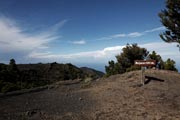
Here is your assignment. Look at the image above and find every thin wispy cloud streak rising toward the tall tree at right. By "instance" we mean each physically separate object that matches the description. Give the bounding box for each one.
[98,27,165,40]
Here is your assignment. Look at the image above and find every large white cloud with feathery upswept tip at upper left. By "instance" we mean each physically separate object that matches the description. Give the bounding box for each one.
[0,17,66,53]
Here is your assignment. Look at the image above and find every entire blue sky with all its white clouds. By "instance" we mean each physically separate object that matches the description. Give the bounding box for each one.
[0,0,180,71]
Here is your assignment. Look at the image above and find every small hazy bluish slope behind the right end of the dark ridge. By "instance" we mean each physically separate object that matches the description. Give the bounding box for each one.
[80,67,104,78]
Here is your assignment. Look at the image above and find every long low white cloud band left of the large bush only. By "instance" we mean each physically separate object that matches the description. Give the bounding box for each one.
[28,46,124,62]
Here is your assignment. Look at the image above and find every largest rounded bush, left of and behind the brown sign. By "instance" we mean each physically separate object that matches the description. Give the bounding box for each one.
[105,44,149,77]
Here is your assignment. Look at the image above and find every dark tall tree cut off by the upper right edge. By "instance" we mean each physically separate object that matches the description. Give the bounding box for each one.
[159,0,180,50]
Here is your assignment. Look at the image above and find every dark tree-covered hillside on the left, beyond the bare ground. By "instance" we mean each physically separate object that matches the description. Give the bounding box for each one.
[0,61,104,93]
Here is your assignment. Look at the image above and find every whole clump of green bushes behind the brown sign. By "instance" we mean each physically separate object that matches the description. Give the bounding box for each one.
[105,44,177,77]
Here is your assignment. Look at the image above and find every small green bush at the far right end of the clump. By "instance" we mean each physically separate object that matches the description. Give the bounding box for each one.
[164,58,177,71]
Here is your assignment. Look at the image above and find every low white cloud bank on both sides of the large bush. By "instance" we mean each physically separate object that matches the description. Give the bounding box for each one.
[28,42,180,64]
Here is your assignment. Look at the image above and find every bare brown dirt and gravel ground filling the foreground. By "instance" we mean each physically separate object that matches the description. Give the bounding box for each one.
[0,70,180,120]
